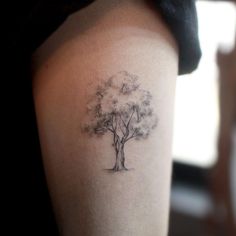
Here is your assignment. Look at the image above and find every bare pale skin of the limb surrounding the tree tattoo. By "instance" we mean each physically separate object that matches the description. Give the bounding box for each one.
[32,0,178,236]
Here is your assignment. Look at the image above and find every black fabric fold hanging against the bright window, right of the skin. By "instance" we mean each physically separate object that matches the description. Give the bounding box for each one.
[155,0,201,75]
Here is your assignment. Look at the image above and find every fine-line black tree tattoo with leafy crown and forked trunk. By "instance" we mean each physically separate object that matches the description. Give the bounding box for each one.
[83,71,157,171]
